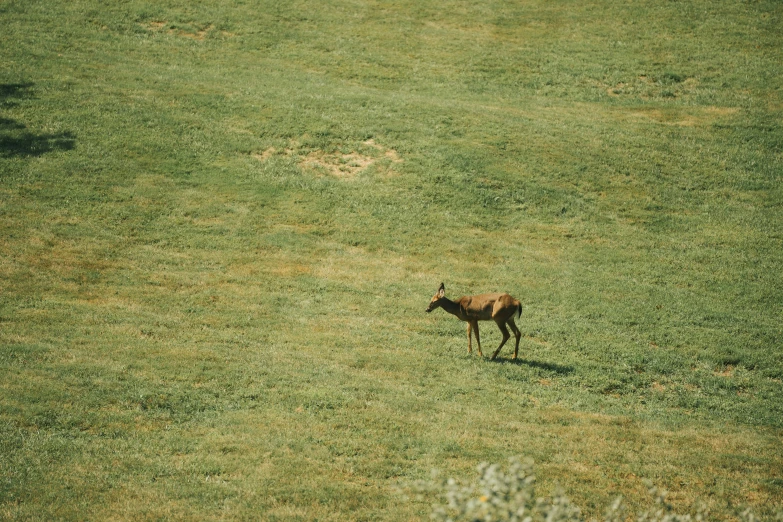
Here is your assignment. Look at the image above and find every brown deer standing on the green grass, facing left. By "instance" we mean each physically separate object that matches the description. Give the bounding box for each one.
[426,283,522,360]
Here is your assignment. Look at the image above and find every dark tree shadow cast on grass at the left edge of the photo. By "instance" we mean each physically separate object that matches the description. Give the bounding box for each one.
[0,83,76,158]
